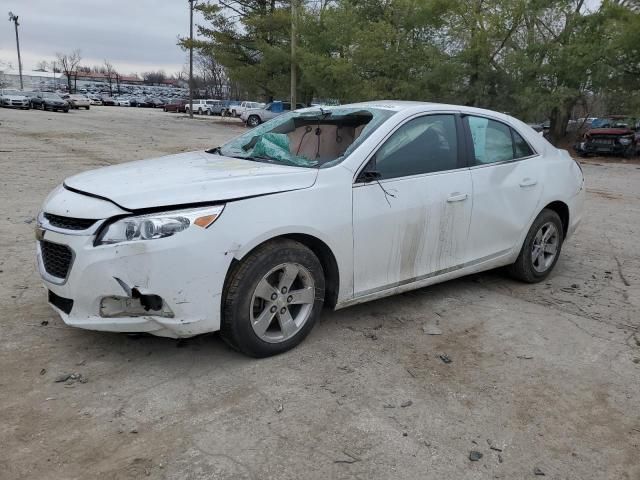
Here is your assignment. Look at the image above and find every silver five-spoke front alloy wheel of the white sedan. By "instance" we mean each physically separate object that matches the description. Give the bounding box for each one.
[250,263,315,343]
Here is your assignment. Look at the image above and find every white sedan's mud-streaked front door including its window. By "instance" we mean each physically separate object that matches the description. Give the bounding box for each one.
[353,113,472,296]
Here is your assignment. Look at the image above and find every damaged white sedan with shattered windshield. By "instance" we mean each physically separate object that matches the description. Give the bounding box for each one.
[36,101,585,357]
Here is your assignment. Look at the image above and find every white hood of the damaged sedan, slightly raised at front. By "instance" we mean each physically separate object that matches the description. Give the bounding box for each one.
[64,152,318,210]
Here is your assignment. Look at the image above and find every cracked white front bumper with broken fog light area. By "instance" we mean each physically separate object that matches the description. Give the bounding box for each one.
[37,212,231,338]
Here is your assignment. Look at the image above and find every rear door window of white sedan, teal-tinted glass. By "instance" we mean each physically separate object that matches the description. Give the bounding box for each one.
[464,116,514,165]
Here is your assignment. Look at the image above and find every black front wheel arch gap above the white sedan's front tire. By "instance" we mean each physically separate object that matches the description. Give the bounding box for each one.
[223,233,340,308]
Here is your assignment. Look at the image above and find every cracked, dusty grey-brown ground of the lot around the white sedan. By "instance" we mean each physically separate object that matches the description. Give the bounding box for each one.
[0,107,640,480]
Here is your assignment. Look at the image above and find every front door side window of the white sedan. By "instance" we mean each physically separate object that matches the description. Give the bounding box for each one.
[374,115,458,178]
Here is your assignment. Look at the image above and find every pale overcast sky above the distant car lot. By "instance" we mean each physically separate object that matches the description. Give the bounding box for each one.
[0,0,202,74]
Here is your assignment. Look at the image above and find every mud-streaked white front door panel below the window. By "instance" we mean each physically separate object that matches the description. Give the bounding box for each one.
[353,168,472,296]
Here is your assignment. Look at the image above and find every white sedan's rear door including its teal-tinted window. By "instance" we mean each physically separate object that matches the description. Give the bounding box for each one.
[463,115,543,263]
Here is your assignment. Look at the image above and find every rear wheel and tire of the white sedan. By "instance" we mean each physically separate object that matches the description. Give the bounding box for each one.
[507,208,564,283]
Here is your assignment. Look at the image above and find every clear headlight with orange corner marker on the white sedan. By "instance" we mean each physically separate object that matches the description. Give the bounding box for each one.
[96,205,224,245]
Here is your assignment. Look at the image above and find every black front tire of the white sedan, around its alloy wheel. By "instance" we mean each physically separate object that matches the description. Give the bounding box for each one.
[221,240,324,358]
